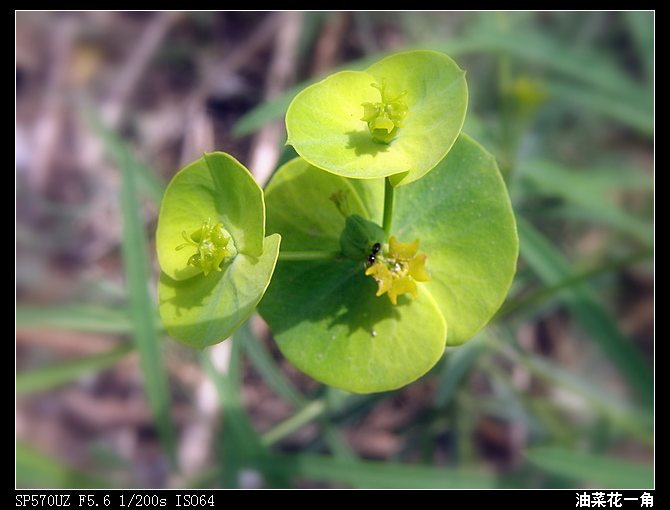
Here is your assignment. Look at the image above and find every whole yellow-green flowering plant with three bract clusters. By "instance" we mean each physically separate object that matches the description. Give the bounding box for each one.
[157,51,518,393]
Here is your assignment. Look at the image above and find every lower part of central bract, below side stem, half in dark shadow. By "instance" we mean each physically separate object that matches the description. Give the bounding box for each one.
[260,260,447,393]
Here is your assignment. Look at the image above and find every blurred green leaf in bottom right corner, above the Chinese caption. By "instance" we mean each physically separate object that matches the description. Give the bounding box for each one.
[525,447,654,489]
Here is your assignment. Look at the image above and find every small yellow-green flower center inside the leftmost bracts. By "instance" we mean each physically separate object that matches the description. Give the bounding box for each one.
[175,218,236,276]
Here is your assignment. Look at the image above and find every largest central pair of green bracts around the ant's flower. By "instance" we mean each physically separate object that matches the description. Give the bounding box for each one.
[259,135,518,393]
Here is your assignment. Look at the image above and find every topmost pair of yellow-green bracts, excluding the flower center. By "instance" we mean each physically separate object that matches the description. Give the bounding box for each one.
[286,50,468,186]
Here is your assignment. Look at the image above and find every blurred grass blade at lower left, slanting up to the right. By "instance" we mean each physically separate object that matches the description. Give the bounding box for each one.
[16,346,131,395]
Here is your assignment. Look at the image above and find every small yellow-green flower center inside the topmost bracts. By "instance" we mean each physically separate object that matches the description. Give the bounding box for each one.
[361,79,408,143]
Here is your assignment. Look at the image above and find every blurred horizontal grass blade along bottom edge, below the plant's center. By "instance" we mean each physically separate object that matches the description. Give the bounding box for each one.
[264,454,495,489]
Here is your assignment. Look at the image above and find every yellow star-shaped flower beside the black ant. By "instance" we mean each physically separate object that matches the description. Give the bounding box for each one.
[365,236,430,305]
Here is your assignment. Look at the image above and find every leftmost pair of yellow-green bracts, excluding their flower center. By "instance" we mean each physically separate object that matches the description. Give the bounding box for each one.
[156,152,280,348]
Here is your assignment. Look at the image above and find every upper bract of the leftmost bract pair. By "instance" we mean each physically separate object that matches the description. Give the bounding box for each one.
[156,152,265,280]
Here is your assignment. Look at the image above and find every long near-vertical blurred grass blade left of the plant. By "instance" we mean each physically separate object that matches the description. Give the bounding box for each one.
[113,128,177,465]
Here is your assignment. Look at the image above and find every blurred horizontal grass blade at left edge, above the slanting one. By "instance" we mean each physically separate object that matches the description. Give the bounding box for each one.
[16,305,163,335]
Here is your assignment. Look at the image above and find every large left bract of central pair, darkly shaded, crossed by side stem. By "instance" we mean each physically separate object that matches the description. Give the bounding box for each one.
[259,159,446,393]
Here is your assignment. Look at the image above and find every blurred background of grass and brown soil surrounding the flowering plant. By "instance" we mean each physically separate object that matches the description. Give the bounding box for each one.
[16,12,654,488]
